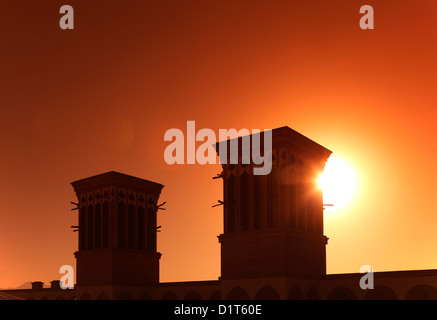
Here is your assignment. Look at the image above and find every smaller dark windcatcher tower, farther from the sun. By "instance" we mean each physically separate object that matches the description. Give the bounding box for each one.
[72,171,163,287]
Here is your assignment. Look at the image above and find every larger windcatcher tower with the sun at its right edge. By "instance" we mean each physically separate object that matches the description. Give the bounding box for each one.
[218,127,331,279]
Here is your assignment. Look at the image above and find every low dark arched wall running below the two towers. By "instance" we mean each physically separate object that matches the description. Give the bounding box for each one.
[2,270,437,300]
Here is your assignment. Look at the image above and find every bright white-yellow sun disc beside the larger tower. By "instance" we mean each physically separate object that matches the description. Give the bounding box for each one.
[318,155,357,209]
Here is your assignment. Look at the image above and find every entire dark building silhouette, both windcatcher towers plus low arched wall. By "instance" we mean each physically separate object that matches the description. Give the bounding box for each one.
[0,127,437,300]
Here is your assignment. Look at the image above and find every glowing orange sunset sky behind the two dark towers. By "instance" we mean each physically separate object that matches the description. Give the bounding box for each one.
[0,0,437,287]
